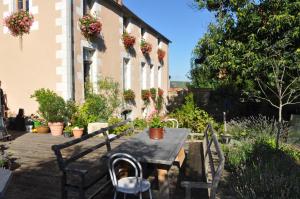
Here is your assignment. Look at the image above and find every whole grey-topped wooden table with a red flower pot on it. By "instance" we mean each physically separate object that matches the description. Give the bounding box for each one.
[108,128,190,199]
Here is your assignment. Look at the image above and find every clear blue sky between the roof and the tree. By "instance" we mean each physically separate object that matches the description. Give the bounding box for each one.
[123,0,214,81]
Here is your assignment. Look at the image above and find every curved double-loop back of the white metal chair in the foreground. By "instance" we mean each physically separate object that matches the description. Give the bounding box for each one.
[108,153,143,187]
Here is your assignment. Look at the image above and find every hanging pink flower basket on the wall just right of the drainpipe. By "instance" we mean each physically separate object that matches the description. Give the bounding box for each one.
[79,14,102,41]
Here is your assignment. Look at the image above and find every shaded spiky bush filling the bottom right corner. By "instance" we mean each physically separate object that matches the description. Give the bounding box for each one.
[225,137,300,199]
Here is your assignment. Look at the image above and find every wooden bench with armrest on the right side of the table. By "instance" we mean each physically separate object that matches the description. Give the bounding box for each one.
[181,124,225,199]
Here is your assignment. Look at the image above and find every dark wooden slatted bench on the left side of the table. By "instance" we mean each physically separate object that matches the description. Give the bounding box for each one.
[52,120,133,199]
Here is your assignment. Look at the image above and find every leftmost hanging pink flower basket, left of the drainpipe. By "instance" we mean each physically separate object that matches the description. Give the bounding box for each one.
[4,10,34,37]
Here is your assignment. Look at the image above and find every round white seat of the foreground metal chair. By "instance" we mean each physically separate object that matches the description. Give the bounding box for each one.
[116,177,151,194]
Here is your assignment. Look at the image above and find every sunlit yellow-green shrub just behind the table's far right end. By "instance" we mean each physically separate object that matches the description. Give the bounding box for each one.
[169,94,217,133]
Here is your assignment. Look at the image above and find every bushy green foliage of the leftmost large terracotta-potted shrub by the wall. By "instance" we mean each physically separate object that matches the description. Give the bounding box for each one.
[31,88,69,122]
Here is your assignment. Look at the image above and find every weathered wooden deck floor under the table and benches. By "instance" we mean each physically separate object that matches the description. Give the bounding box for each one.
[0,132,205,199]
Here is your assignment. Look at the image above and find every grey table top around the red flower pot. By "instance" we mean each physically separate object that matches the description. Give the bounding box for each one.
[108,128,190,166]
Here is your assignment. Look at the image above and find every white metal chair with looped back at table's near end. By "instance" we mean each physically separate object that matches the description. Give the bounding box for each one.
[108,153,152,199]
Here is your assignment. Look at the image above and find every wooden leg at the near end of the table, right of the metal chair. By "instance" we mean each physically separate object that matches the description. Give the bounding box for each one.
[157,167,170,199]
